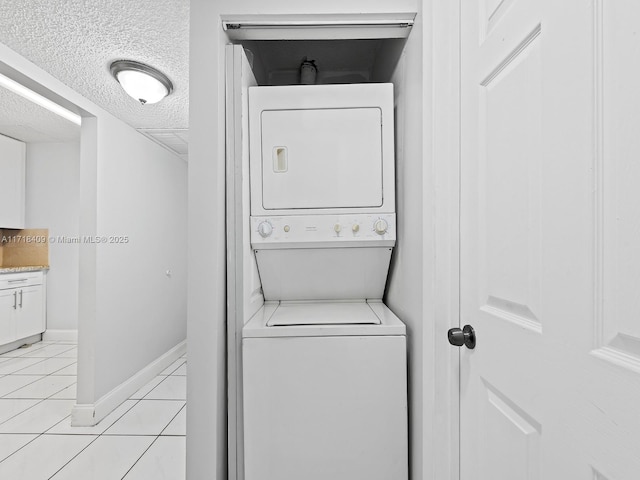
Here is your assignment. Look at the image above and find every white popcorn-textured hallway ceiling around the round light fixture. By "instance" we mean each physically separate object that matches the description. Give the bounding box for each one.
[0,0,189,135]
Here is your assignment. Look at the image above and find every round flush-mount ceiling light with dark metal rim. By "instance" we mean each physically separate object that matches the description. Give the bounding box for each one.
[110,60,173,105]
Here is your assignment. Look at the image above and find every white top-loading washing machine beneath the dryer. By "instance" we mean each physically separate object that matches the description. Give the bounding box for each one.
[242,301,408,480]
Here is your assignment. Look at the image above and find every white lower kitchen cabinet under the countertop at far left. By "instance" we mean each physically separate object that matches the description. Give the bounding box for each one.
[0,272,46,345]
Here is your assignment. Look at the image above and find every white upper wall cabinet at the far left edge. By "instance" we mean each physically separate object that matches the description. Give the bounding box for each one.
[0,131,26,228]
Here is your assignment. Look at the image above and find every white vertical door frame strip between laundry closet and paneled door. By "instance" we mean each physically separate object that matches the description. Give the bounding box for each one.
[420,0,462,480]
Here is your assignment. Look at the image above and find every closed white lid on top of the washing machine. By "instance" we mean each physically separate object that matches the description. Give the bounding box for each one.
[267,301,381,327]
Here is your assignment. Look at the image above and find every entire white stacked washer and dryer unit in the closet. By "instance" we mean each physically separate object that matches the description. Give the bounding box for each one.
[242,84,408,480]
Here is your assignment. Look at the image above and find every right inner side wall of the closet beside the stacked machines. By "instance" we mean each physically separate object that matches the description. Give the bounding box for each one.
[384,10,431,479]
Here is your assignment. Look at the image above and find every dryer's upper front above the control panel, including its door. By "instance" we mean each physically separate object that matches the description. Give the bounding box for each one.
[249,83,395,216]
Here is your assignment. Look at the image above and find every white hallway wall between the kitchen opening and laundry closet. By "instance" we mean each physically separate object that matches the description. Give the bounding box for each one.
[78,114,187,403]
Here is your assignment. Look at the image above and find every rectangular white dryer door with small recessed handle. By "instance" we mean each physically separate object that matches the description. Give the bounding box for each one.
[261,107,382,210]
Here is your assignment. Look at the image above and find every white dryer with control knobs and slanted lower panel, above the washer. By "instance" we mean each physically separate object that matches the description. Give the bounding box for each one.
[249,84,396,300]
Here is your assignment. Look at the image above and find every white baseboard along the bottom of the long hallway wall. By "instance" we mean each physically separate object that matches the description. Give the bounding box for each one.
[71,340,187,427]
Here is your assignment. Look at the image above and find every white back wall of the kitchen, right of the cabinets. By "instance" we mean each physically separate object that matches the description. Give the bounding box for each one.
[26,142,80,330]
